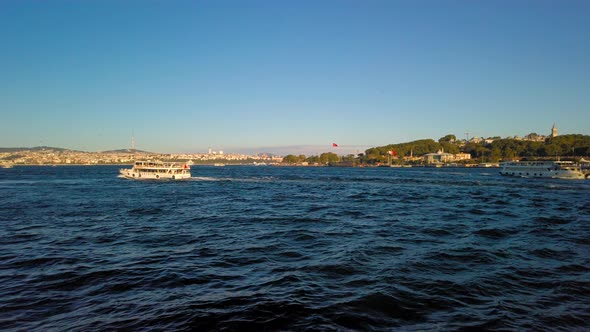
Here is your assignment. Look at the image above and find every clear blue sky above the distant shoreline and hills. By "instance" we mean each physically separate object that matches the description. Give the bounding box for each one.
[0,0,590,152]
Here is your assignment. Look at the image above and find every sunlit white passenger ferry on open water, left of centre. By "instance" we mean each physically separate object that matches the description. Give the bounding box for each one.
[120,160,191,180]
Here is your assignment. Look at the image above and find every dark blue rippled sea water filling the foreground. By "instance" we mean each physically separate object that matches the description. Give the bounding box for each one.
[0,166,590,331]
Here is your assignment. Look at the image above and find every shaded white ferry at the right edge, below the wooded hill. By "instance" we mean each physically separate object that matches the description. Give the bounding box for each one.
[500,161,590,179]
